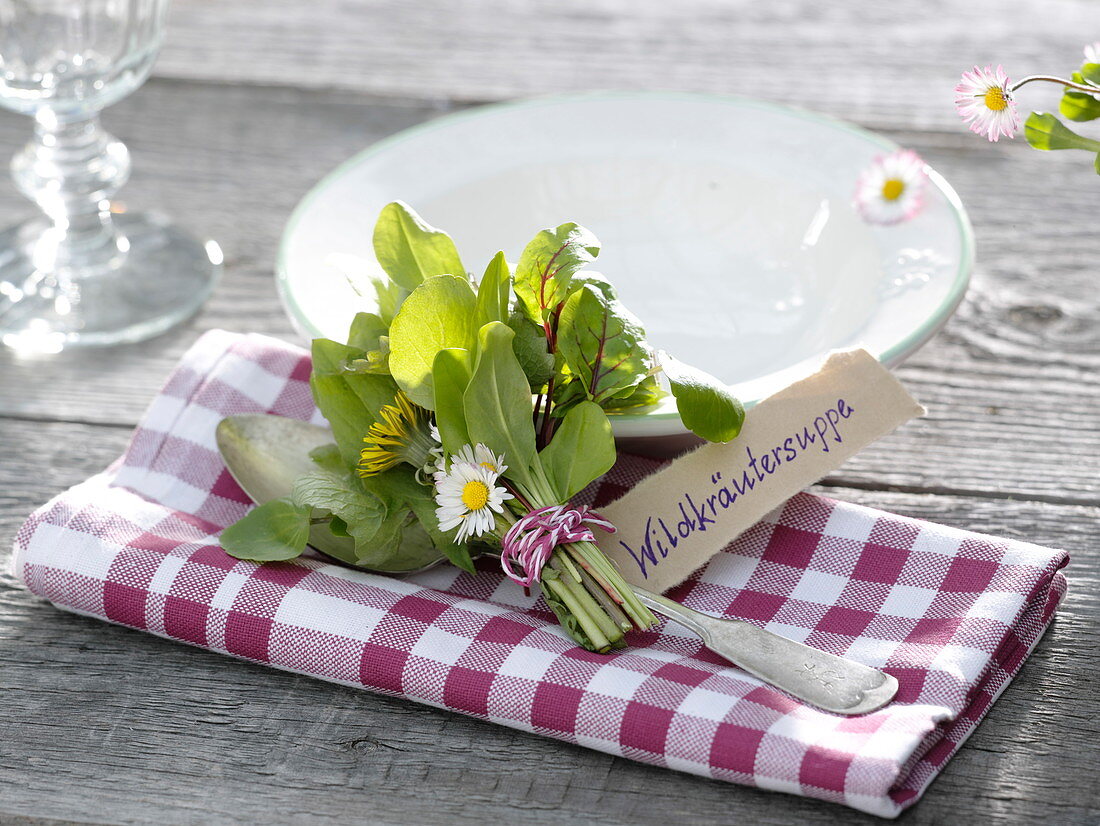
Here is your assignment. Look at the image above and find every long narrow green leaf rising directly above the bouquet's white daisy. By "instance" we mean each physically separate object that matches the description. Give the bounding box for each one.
[463,321,536,487]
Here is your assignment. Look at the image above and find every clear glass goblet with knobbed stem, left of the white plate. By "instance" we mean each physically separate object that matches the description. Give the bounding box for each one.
[0,0,221,353]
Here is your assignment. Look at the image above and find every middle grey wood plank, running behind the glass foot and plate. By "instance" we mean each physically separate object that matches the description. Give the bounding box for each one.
[0,81,1100,504]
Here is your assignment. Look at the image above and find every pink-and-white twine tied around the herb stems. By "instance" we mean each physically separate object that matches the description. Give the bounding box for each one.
[501,505,615,588]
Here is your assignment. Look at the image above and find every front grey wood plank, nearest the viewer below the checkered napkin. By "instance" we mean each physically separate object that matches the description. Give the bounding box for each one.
[0,420,1100,824]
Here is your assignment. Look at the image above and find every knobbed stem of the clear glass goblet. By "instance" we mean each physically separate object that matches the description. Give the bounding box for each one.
[11,110,130,280]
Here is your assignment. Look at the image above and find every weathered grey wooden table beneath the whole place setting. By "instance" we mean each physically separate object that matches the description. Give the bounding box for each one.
[0,0,1100,824]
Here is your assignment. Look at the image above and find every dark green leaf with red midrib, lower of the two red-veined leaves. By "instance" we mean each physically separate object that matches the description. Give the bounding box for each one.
[558,285,653,403]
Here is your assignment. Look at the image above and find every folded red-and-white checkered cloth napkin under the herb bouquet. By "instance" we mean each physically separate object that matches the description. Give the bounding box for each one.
[13,332,1067,817]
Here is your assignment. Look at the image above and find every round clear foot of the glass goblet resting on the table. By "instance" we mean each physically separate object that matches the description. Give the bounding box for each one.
[0,212,222,354]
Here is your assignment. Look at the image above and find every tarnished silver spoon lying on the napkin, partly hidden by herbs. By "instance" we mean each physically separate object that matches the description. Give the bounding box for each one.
[217,415,898,715]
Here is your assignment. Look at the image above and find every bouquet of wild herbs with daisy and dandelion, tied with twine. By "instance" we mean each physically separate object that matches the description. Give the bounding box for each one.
[221,202,745,651]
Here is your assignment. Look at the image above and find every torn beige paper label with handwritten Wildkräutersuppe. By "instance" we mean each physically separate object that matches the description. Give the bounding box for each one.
[596,350,924,593]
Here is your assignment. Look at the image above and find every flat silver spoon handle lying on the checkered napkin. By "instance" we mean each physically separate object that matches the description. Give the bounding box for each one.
[634,587,898,715]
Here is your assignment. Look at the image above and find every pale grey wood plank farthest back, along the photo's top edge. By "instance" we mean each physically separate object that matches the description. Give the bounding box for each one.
[156,0,1100,128]
